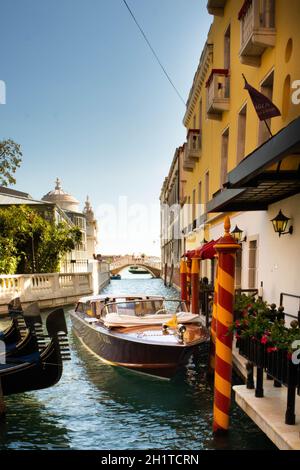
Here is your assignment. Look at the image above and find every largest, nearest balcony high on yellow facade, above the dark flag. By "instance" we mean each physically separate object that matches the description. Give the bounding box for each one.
[238,0,276,67]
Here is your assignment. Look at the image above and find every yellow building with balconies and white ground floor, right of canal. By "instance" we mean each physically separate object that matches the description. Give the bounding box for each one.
[162,0,300,309]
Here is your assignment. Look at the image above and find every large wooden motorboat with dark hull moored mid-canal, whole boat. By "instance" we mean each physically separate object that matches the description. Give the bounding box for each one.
[70,295,209,379]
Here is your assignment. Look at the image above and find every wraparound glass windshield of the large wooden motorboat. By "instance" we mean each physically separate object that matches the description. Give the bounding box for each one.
[101,299,188,317]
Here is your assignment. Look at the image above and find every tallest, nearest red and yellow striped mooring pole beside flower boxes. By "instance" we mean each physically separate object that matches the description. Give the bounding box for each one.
[213,216,240,434]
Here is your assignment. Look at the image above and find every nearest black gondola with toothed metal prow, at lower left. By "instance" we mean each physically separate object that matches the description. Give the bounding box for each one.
[0,308,70,396]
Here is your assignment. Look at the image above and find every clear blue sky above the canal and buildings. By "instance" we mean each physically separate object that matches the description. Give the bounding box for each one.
[0,0,211,253]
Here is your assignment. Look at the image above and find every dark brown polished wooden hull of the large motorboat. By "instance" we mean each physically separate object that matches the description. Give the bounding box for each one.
[71,312,207,379]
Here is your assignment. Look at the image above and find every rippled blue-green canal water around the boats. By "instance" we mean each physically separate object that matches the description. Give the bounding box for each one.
[0,271,274,450]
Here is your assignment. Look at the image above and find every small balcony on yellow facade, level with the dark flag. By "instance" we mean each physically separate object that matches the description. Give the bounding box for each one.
[206,69,230,120]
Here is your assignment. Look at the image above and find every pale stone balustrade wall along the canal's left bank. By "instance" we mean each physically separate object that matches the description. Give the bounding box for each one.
[0,261,110,315]
